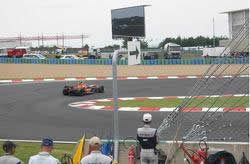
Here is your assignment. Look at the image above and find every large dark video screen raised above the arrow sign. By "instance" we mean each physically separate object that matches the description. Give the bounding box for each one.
[111,6,145,39]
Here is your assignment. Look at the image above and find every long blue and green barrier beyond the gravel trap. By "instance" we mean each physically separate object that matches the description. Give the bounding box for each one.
[0,57,249,65]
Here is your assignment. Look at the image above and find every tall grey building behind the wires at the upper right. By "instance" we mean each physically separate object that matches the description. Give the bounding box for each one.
[220,8,249,52]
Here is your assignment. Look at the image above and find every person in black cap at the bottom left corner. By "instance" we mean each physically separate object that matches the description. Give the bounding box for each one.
[0,141,23,164]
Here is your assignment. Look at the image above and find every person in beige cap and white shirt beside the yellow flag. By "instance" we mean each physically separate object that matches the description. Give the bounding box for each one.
[81,137,112,164]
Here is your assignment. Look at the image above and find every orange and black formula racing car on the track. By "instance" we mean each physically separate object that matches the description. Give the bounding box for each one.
[63,82,104,96]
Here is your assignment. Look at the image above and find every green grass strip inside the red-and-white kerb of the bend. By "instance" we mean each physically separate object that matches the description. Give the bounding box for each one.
[97,96,249,108]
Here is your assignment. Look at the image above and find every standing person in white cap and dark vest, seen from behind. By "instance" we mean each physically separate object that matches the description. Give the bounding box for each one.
[137,113,158,164]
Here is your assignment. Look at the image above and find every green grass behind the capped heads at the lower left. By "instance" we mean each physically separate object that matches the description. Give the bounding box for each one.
[0,142,75,163]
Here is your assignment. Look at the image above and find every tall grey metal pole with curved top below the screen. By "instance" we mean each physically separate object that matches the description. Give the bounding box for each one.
[112,50,119,163]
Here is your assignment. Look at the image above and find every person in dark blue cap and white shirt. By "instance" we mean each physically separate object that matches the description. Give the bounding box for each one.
[29,138,60,164]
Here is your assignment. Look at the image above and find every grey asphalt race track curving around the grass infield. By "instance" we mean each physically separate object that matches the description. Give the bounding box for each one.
[0,78,249,142]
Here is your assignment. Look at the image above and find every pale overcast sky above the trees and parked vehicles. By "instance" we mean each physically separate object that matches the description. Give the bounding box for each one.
[0,0,249,47]
